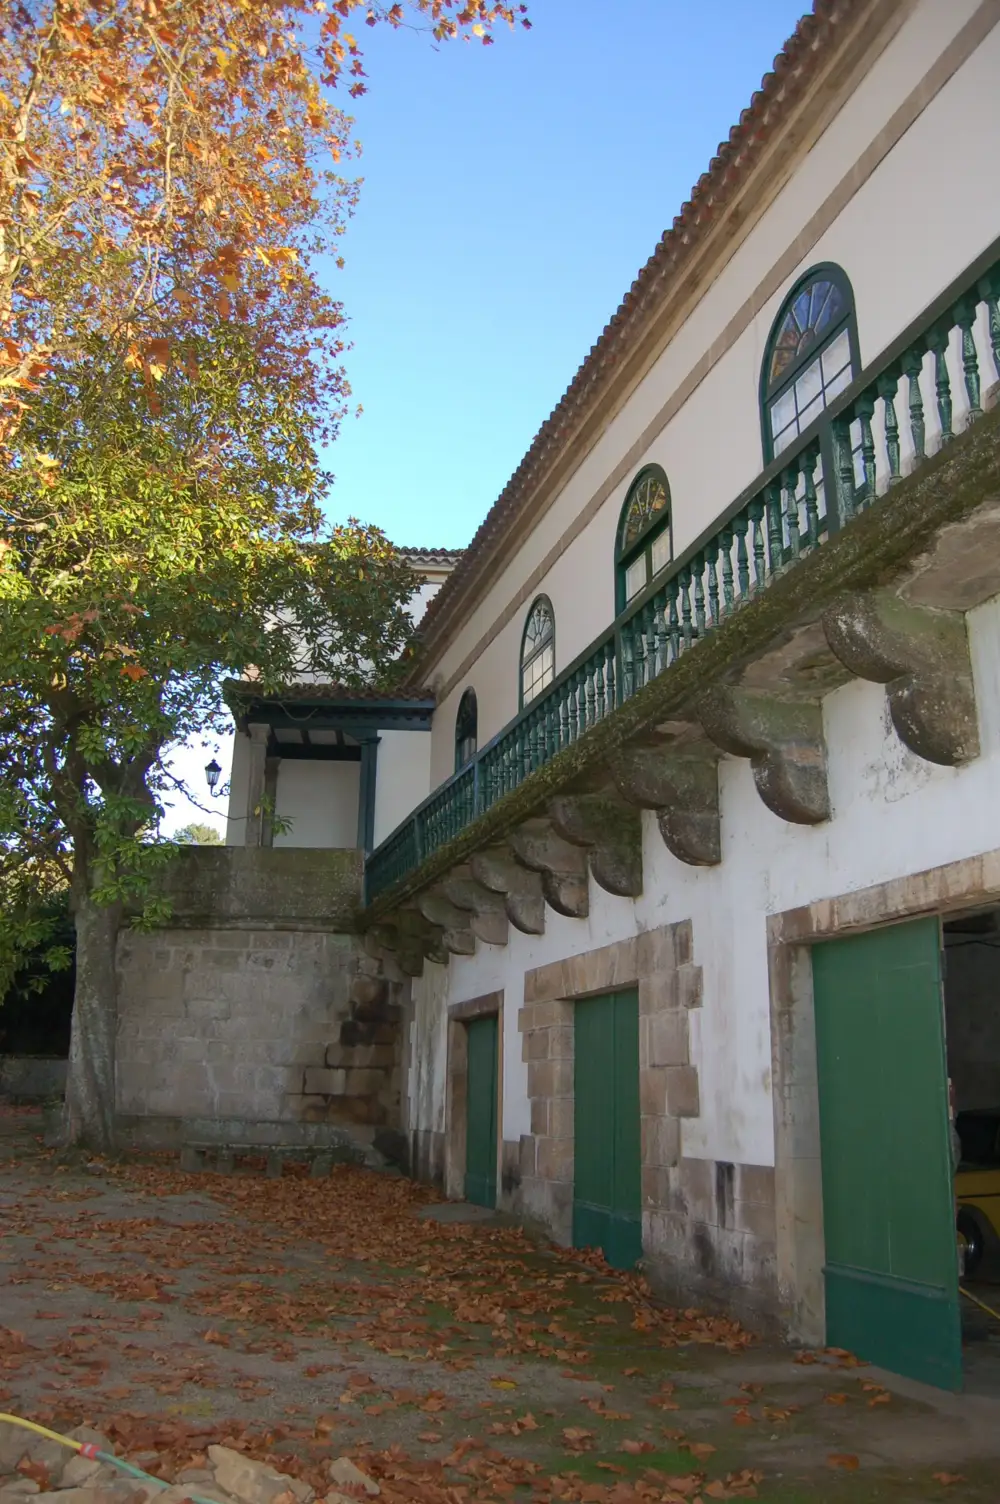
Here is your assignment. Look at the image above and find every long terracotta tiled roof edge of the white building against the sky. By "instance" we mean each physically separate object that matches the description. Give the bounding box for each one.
[411,0,865,675]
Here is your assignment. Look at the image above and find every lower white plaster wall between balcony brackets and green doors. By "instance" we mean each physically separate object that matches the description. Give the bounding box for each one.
[414,597,1000,1164]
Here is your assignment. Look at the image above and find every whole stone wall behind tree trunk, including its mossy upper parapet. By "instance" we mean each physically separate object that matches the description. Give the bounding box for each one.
[117,847,402,1146]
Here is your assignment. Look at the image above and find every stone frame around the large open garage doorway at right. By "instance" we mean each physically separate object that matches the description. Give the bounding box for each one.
[767,850,1000,1345]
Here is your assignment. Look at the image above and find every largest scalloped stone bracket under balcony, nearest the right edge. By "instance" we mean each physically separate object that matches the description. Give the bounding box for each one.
[823,591,979,767]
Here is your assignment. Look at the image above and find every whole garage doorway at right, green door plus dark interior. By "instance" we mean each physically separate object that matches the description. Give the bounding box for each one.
[812,907,1000,1396]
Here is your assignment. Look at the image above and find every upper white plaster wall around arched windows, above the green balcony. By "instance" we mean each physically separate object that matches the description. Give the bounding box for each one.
[432,0,1000,787]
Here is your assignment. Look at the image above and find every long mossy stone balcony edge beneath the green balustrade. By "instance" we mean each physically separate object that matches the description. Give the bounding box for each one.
[361,408,1000,926]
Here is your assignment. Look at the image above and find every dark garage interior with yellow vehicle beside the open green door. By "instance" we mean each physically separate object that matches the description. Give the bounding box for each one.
[943,908,1000,1394]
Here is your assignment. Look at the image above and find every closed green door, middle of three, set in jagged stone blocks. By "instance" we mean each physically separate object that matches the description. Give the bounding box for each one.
[573,991,642,1269]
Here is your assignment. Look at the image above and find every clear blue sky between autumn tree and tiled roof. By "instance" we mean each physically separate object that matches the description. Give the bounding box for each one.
[326,0,805,547]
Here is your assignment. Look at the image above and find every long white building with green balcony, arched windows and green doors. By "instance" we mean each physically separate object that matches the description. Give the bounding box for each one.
[224,0,1000,1387]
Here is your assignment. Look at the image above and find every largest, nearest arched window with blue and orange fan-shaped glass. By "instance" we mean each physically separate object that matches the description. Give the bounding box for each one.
[761,263,860,462]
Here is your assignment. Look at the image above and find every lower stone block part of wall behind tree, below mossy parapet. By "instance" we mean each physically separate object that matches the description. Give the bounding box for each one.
[117,929,400,1126]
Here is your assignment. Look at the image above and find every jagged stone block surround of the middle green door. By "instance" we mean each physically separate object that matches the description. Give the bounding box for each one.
[517,920,702,1244]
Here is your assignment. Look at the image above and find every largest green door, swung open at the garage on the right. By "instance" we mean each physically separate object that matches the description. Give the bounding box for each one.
[812,919,962,1390]
